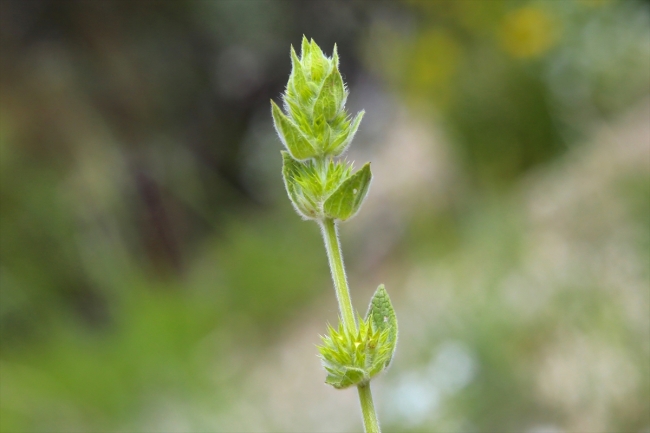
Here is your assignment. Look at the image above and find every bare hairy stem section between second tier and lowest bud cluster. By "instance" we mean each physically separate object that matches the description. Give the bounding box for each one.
[321,218,357,331]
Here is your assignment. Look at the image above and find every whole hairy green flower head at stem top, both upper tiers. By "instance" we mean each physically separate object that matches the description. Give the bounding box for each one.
[271,37,372,221]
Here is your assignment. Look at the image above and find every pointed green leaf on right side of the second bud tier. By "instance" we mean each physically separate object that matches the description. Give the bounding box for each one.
[323,163,372,221]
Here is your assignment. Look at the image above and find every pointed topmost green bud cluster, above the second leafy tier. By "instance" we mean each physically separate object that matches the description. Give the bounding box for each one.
[271,36,364,161]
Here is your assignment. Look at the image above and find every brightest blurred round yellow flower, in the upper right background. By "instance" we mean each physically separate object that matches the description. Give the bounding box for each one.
[499,6,557,58]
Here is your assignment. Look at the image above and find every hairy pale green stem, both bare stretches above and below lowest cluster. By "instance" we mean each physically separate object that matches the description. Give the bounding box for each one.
[321,218,381,433]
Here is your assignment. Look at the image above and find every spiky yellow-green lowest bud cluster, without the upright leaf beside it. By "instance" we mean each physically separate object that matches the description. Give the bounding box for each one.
[318,317,392,389]
